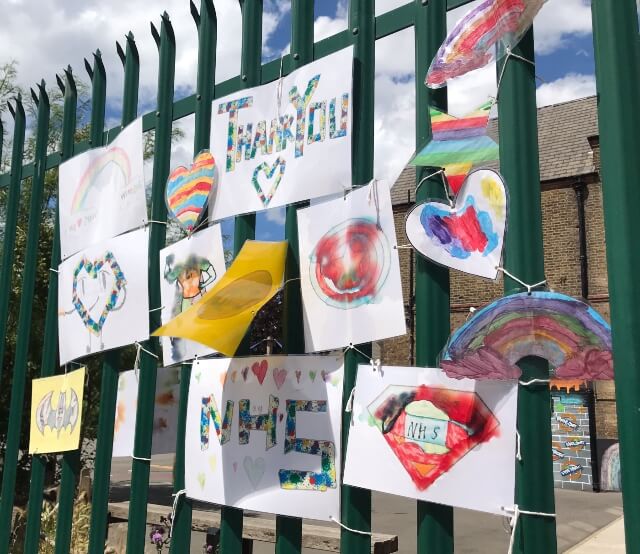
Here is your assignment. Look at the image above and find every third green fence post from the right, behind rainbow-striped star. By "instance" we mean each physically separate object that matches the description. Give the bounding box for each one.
[414,0,453,554]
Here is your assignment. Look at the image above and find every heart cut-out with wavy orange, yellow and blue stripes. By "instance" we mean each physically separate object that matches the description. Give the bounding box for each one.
[166,150,216,232]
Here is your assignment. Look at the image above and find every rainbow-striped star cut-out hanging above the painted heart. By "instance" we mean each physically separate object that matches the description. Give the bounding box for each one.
[410,102,499,194]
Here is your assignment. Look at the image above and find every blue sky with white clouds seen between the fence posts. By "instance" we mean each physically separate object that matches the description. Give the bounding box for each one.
[0,0,595,247]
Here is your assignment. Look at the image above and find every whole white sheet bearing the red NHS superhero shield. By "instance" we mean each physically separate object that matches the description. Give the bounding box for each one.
[344,365,518,515]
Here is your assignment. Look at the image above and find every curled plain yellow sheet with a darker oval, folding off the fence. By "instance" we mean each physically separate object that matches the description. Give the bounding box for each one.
[153,240,287,356]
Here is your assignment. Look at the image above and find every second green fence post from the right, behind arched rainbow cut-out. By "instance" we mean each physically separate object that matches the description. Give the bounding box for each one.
[498,30,557,554]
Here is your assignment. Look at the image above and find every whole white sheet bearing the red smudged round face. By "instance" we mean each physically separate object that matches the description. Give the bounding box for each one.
[298,182,406,352]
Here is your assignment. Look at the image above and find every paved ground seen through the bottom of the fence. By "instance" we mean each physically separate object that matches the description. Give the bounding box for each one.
[111,456,624,554]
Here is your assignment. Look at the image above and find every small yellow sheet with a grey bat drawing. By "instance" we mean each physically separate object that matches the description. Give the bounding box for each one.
[29,367,85,454]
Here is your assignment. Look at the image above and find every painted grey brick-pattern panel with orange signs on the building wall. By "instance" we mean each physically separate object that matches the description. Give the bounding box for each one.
[551,392,593,490]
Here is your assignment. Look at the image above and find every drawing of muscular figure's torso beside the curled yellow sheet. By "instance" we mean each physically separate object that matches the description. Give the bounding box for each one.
[164,254,217,360]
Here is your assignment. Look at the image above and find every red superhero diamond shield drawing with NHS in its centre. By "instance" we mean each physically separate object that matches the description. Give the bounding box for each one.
[368,385,500,491]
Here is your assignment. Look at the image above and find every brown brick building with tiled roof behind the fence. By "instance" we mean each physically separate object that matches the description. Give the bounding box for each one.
[378,97,617,489]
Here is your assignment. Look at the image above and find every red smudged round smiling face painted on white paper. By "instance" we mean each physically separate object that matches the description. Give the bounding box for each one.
[309,218,391,310]
